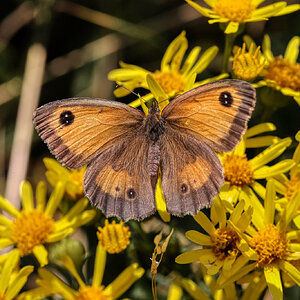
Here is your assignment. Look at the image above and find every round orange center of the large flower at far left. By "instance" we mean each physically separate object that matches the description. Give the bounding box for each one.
[12,210,55,256]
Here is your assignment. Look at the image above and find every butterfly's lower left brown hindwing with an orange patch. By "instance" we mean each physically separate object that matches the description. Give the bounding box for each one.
[84,132,156,221]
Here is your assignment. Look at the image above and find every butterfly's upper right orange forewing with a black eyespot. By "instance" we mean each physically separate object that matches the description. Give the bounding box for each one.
[162,80,255,152]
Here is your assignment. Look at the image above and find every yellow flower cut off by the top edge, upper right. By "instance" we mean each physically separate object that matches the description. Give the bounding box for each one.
[185,0,300,33]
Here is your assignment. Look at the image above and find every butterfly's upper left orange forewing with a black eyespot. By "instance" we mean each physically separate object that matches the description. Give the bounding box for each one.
[33,98,144,168]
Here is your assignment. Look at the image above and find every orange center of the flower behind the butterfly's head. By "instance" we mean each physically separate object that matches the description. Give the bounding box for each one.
[152,70,185,95]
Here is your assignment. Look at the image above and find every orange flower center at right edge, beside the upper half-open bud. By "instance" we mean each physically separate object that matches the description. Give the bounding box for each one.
[265,57,300,92]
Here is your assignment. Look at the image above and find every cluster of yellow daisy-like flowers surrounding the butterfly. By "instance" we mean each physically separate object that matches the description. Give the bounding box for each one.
[0,0,300,300]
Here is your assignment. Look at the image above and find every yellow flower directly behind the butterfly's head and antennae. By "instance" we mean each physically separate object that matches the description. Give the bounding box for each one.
[108,31,228,107]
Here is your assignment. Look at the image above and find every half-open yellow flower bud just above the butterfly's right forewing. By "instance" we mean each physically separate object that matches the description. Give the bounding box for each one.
[232,43,265,81]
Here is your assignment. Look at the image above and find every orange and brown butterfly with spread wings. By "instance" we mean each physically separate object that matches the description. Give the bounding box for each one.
[34,80,255,221]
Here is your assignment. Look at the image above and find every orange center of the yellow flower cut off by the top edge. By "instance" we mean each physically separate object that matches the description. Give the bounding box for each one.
[214,0,256,23]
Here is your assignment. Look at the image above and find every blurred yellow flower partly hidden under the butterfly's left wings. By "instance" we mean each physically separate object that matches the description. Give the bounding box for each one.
[43,157,86,199]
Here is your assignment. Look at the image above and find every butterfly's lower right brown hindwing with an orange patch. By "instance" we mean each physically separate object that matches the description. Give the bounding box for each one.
[161,128,224,216]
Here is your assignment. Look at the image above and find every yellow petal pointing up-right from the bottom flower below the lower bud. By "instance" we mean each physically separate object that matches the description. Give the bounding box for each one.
[104,263,145,299]
